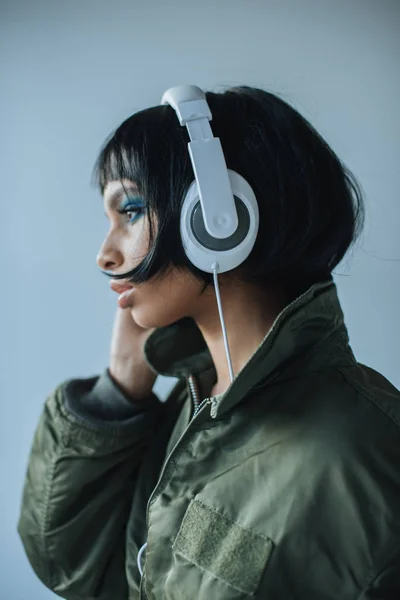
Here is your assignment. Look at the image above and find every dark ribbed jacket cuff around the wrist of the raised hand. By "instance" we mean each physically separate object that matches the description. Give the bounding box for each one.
[63,368,162,426]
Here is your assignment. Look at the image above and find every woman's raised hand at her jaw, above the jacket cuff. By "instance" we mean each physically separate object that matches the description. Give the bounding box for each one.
[109,306,157,402]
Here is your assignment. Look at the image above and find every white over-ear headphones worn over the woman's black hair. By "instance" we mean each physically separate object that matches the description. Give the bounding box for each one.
[161,85,259,273]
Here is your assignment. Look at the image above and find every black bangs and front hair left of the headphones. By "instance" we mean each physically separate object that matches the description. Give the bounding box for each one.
[92,106,206,283]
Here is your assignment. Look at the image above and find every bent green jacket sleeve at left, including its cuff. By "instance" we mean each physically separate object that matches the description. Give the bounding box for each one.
[18,369,165,600]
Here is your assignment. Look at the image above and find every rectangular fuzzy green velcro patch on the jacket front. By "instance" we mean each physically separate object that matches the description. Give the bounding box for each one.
[172,500,273,595]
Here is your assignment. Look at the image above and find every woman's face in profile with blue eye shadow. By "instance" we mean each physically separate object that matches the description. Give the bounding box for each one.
[97,180,203,328]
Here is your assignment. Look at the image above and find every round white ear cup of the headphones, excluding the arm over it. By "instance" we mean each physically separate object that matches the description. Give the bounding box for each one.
[180,169,259,273]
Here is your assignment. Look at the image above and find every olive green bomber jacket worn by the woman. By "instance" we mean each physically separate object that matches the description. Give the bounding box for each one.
[18,281,400,600]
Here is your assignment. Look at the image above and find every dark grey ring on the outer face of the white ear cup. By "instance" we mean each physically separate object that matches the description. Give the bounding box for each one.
[190,196,250,251]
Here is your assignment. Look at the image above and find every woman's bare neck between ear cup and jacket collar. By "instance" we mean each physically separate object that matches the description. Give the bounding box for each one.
[192,275,287,395]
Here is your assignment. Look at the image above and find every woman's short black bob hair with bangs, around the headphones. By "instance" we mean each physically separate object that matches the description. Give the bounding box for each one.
[94,86,364,293]
